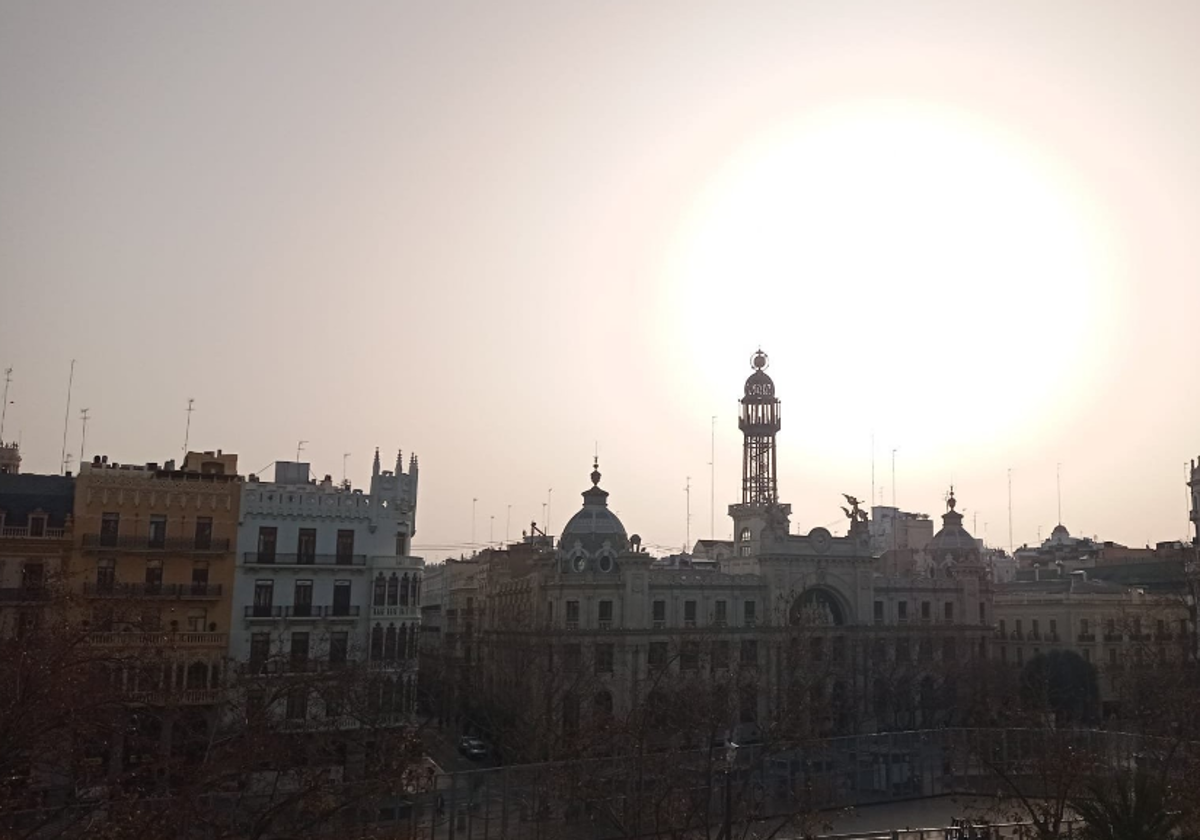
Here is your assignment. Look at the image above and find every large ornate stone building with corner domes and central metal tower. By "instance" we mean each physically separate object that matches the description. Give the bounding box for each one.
[430,353,992,758]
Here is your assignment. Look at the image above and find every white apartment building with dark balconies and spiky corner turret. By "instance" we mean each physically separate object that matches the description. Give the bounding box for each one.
[230,450,425,720]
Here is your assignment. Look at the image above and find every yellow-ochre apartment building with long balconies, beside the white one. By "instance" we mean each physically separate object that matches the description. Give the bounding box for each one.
[71,450,241,706]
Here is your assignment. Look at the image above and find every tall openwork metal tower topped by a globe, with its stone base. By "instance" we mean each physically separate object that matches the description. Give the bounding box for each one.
[730,349,792,557]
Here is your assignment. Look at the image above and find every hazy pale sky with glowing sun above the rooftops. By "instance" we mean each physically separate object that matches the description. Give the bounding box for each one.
[0,0,1200,559]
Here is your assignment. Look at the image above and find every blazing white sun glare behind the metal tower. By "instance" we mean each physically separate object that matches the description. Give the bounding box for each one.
[667,103,1114,463]
